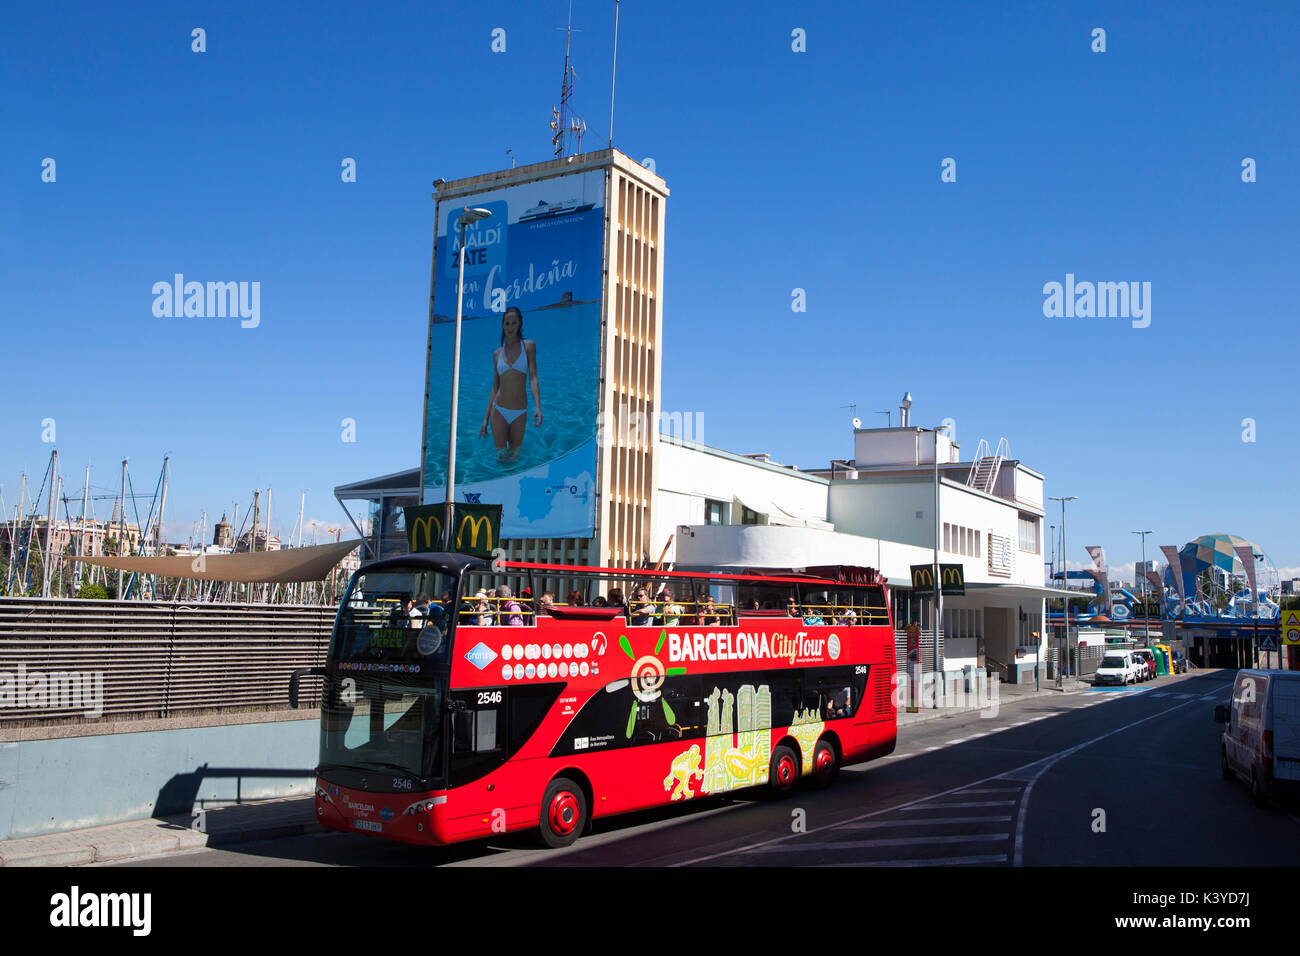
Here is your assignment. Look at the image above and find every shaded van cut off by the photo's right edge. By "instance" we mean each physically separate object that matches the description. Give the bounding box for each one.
[1214,670,1300,806]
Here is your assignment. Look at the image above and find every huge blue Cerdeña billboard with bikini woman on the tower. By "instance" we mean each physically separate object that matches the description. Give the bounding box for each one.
[423,164,605,537]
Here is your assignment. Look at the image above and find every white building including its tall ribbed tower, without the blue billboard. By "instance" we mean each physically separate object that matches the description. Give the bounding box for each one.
[334,150,1057,682]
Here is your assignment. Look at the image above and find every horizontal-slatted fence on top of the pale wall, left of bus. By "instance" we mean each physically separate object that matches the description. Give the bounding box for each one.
[0,598,335,727]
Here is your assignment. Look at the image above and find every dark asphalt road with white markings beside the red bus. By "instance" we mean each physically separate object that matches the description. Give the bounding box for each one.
[114,671,1300,866]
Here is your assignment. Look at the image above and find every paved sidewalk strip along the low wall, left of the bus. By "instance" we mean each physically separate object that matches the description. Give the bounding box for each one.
[0,796,320,866]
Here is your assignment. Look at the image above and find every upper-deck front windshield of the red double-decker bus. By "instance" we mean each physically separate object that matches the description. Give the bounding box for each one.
[330,568,456,674]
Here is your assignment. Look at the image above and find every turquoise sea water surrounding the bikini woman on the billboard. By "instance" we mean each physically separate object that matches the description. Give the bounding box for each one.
[425,303,601,486]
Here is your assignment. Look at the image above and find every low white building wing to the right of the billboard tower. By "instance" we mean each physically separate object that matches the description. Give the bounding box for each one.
[653,395,1054,682]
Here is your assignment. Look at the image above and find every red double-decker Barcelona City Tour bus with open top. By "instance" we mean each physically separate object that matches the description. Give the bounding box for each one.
[290,553,896,847]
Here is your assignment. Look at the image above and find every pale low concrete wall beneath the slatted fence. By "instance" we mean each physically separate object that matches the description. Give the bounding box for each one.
[0,711,320,839]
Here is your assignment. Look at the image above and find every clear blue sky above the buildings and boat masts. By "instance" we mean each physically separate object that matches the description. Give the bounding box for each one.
[0,0,1300,568]
